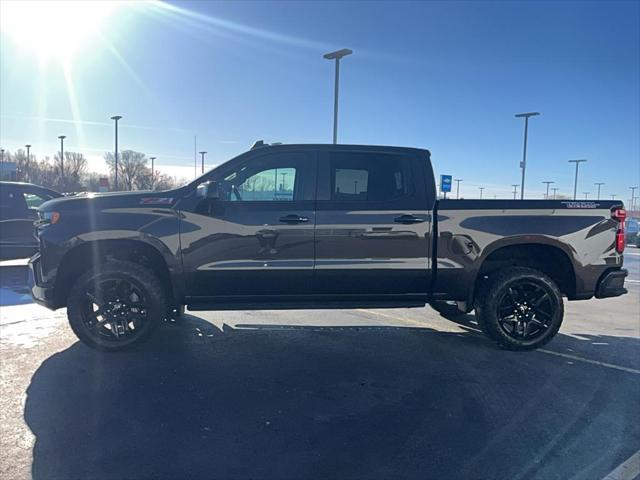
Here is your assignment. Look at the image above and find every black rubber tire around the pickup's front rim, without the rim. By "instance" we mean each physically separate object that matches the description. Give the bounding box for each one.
[67,260,167,352]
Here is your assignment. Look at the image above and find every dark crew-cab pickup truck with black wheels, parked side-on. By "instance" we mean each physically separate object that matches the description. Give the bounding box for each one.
[30,143,627,350]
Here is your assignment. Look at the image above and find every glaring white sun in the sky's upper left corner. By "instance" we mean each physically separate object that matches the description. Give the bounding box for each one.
[0,0,121,60]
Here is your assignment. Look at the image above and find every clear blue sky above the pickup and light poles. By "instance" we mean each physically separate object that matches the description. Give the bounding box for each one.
[0,1,640,201]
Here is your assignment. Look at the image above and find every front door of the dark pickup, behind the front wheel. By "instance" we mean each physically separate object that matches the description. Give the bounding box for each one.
[180,151,317,301]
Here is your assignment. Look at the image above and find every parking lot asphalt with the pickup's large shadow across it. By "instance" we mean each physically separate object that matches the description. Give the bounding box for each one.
[0,248,640,479]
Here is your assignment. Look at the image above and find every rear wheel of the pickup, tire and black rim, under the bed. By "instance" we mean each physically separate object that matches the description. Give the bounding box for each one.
[476,267,564,350]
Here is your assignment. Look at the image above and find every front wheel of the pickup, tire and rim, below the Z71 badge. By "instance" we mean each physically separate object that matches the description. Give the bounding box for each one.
[67,260,167,351]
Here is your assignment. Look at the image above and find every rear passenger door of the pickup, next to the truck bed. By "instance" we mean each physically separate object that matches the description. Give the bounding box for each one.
[314,149,433,299]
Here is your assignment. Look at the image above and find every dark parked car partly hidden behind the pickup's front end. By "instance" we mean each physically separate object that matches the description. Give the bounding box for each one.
[0,182,61,260]
